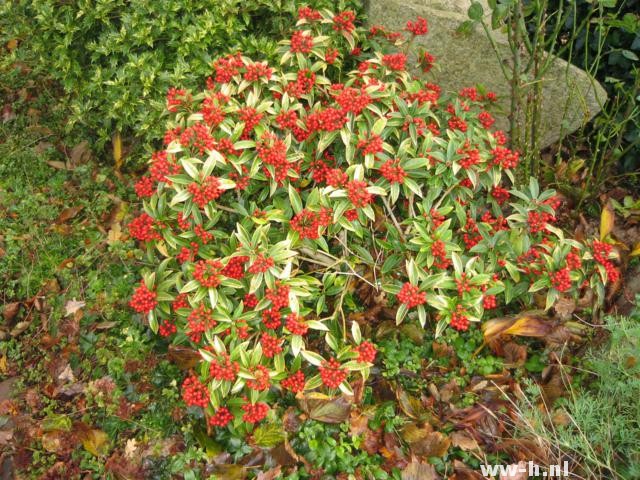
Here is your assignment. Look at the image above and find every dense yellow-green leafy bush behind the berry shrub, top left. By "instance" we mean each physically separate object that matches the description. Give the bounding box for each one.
[0,0,360,158]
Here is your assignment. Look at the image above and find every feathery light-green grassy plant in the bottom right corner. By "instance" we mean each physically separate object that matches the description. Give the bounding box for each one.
[520,302,640,480]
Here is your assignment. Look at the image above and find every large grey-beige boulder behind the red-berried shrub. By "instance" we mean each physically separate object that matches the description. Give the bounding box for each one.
[367,0,607,148]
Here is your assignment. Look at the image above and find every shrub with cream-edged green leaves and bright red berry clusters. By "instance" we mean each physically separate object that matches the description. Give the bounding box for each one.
[130,8,618,432]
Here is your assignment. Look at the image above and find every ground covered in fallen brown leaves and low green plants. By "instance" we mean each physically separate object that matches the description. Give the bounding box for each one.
[0,23,640,480]
